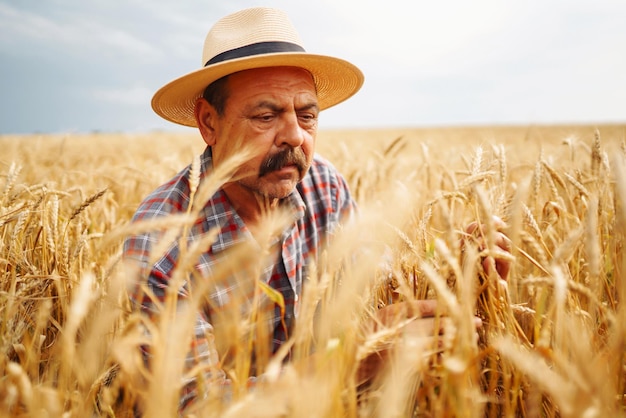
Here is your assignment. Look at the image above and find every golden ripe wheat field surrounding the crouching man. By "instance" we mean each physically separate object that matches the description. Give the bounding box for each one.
[0,126,626,418]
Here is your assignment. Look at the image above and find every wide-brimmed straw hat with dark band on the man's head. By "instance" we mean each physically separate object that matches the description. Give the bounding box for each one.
[152,8,363,126]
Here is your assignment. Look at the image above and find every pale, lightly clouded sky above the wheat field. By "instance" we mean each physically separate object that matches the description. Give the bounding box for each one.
[0,0,626,134]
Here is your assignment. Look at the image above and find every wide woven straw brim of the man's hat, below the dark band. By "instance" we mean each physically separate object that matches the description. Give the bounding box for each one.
[152,52,364,127]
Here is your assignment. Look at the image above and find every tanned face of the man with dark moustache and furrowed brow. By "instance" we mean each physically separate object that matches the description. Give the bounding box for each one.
[213,67,319,199]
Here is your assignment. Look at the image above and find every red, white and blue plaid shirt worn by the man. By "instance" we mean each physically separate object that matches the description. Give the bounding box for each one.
[124,147,356,404]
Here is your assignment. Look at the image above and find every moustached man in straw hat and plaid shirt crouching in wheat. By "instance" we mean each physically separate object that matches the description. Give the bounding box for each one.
[124,4,508,414]
